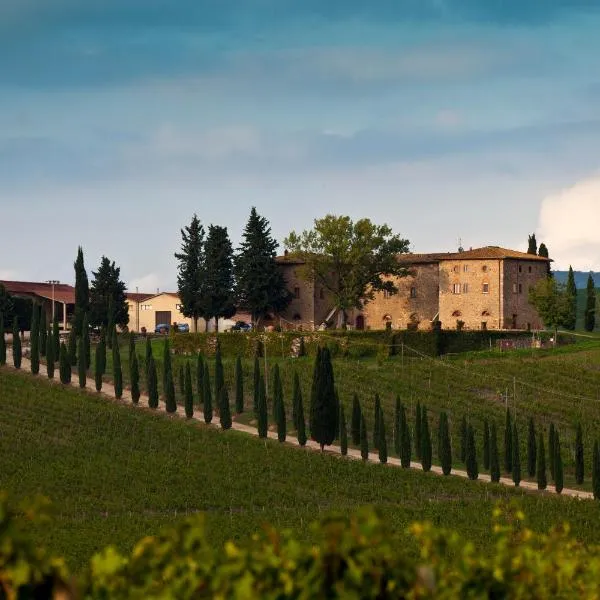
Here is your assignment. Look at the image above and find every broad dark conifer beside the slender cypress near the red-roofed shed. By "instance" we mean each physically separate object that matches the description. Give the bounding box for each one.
[89,256,129,328]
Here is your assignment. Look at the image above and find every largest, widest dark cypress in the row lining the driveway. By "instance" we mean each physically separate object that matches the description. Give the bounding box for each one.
[310,347,339,451]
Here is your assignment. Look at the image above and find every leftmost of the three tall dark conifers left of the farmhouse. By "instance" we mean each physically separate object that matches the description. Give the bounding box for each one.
[175,215,205,332]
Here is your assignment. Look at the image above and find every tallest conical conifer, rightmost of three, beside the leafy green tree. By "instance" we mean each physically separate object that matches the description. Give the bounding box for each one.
[235,207,291,328]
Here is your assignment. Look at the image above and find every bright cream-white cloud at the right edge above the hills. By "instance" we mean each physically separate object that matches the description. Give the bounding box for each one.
[537,175,600,271]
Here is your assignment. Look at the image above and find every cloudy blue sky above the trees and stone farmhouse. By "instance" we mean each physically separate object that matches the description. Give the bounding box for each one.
[0,0,600,292]
